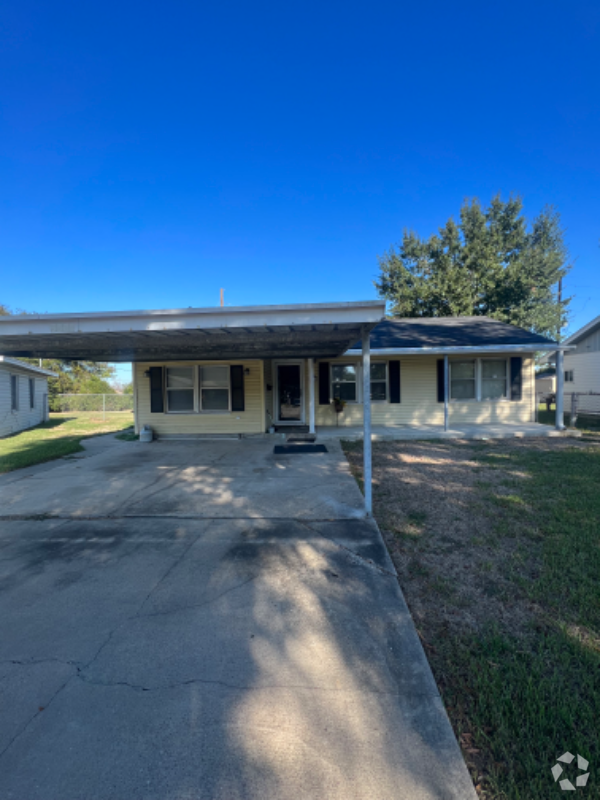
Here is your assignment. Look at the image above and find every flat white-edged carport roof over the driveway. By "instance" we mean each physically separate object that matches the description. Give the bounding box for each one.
[0,300,385,362]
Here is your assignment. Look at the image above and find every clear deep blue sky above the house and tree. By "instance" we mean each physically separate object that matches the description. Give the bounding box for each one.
[0,0,600,382]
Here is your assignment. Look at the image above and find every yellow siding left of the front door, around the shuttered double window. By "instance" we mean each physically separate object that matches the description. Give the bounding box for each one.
[135,360,265,436]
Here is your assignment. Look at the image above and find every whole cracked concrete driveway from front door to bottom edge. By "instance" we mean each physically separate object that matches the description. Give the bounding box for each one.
[0,438,475,800]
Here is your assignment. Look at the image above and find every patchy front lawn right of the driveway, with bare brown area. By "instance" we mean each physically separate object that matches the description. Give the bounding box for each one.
[345,439,600,800]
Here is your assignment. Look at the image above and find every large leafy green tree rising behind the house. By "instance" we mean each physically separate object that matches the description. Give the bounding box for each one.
[375,195,570,338]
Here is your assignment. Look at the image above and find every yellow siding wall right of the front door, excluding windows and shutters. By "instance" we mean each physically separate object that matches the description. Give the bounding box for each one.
[315,353,535,426]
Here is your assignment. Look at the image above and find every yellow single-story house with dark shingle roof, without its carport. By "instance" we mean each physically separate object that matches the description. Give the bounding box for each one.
[134,317,556,436]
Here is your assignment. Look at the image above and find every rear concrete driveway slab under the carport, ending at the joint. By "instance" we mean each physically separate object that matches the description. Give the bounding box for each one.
[0,436,364,519]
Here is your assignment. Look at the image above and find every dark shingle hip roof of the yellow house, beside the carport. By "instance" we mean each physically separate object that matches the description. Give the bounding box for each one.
[352,317,554,350]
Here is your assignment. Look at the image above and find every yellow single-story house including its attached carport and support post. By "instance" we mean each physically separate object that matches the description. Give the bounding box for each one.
[0,300,563,512]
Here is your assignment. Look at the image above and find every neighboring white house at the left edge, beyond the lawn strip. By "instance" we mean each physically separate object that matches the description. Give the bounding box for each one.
[0,356,55,437]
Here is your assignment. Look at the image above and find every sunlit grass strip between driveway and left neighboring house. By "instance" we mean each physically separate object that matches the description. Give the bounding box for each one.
[0,411,133,473]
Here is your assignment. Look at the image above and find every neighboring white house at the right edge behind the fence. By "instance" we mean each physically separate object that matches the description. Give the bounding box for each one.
[562,316,600,414]
